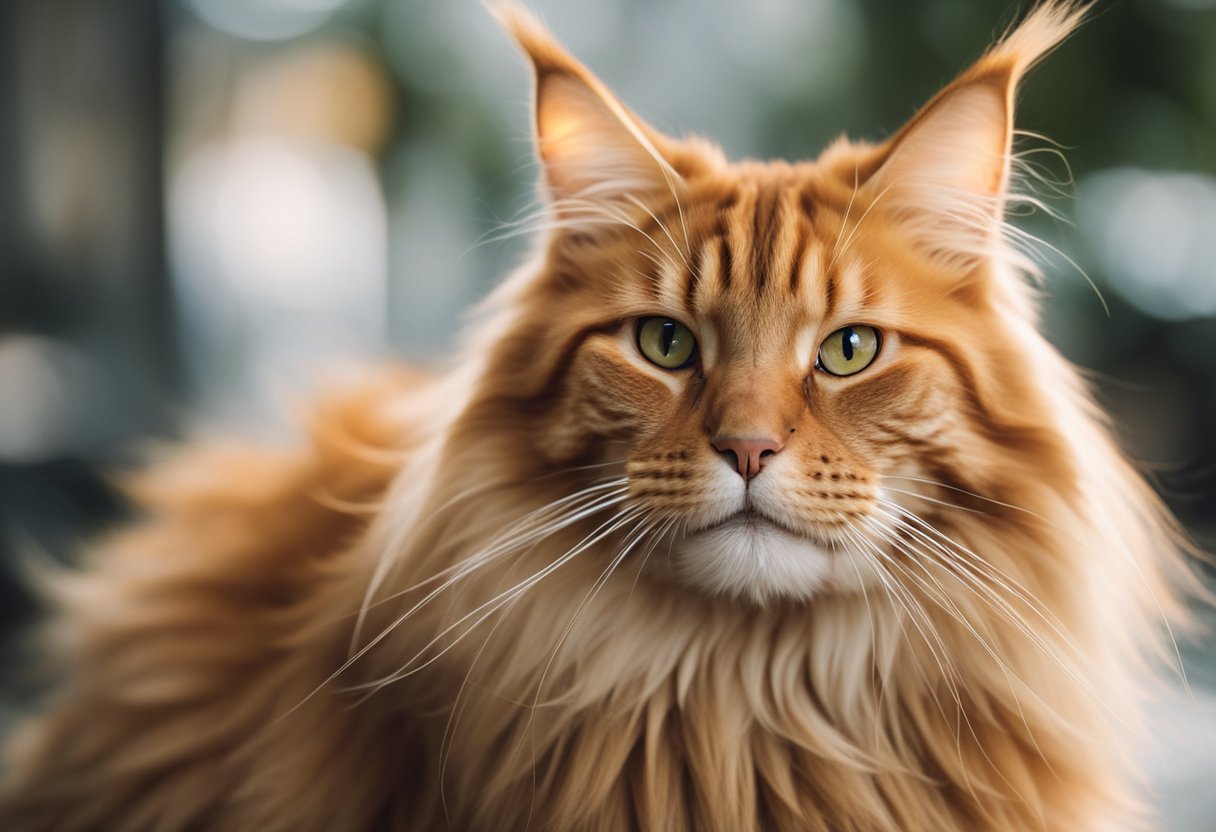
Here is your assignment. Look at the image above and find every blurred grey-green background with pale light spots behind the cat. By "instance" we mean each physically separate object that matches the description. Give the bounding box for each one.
[0,0,1216,831]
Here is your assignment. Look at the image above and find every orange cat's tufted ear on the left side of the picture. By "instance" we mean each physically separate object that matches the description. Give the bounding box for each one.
[494,5,680,214]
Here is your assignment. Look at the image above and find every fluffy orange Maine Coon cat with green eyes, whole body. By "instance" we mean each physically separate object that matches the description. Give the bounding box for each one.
[0,1,1183,832]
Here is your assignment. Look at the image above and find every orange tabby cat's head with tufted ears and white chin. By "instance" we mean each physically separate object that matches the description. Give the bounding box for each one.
[471,2,1083,602]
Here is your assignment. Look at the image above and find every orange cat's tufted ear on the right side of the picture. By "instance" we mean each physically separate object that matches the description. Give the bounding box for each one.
[865,1,1087,265]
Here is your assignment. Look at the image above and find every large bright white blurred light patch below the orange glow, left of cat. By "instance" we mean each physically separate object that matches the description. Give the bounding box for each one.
[169,137,388,418]
